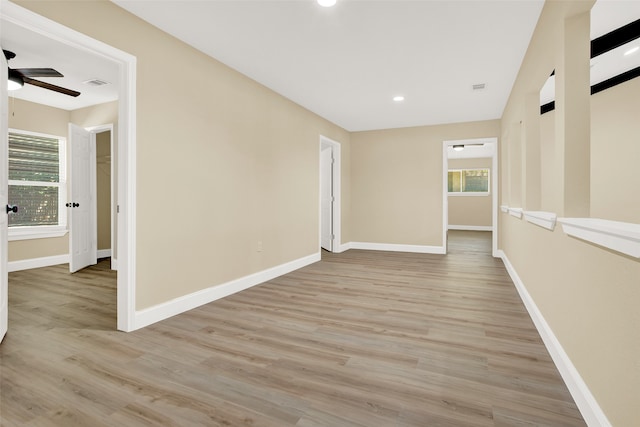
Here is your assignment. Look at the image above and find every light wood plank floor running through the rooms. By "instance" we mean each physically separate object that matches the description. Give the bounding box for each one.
[0,232,585,427]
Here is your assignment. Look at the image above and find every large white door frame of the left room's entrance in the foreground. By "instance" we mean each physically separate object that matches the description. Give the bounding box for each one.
[0,0,138,332]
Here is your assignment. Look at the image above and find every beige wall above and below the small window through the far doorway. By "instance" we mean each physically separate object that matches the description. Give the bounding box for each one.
[448,159,493,227]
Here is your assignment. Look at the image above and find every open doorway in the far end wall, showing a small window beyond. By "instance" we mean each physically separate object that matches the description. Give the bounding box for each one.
[442,137,498,257]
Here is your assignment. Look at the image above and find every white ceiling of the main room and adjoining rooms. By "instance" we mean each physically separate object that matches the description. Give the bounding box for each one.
[0,0,640,131]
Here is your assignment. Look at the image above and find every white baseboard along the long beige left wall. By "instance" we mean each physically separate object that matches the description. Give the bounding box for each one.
[133,252,320,330]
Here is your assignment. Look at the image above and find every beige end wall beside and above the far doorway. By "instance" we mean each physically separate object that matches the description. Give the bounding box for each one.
[351,120,500,246]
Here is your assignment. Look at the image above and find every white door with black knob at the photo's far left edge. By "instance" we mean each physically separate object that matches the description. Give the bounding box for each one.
[0,48,9,342]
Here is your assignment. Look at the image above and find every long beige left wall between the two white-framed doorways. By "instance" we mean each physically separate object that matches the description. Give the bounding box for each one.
[18,1,350,309]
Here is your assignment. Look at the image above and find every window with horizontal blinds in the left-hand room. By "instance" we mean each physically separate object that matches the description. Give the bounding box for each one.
[9,131,66,227]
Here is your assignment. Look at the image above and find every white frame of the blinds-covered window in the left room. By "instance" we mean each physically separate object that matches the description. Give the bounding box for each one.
[7,128,68,241]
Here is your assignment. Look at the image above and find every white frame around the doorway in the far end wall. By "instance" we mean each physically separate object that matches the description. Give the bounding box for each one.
[442,137,499,257]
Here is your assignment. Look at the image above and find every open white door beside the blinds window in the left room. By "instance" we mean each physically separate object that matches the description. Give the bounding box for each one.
[67,123,98,273]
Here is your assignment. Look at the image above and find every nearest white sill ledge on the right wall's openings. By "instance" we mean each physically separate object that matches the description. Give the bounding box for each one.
[558,218,640,258]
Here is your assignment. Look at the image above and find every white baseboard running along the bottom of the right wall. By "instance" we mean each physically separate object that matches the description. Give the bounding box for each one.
[498,250,611,427]
